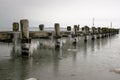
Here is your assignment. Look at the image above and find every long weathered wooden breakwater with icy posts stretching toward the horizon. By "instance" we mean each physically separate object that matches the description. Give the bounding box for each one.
[0,19,119,56]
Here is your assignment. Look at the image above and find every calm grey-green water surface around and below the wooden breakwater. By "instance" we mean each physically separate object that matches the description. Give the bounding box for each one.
[0,35,120,80]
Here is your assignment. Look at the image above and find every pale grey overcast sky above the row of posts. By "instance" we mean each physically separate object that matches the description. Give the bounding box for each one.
[0,0,120,28]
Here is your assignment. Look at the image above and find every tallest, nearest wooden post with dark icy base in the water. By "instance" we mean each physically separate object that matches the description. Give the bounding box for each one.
[20,19,30,56]
